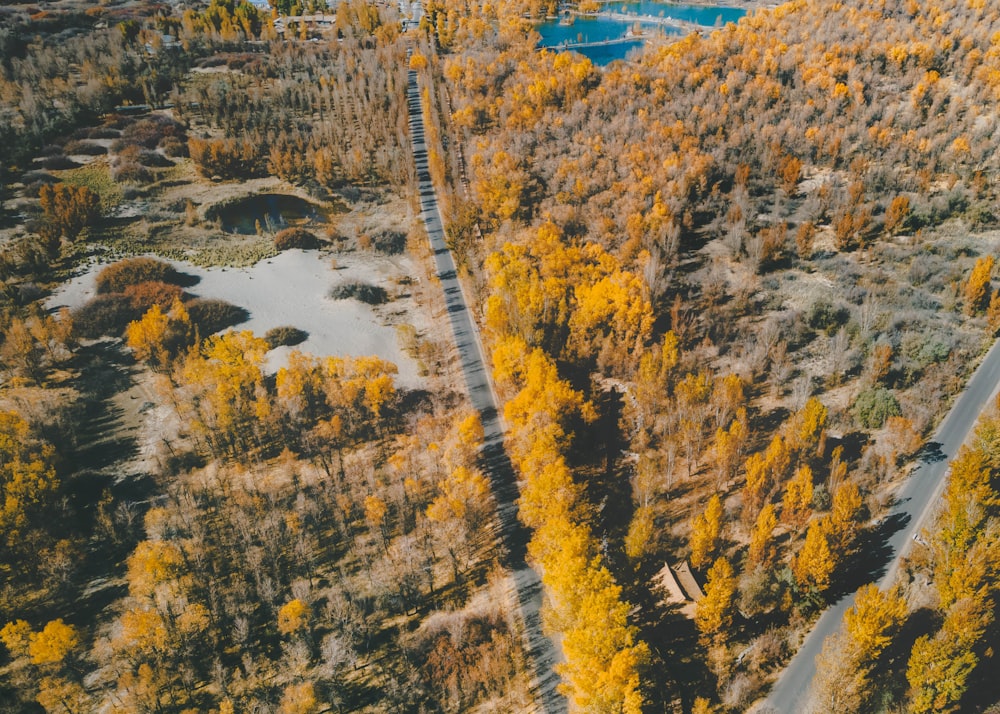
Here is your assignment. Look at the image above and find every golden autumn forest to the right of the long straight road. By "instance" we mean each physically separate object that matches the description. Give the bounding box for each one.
[426,1,1000,712]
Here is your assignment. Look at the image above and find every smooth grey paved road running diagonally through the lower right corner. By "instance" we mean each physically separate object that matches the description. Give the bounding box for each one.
[758,342,1000,714]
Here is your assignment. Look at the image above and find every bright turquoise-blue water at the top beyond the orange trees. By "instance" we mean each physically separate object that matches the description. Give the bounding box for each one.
[535,0,746,65]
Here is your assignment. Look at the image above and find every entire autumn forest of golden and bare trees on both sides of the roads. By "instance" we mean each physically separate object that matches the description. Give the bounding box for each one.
[0,0,1000,714]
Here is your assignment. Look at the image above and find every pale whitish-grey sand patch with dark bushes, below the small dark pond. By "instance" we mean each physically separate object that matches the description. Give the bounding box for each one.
[48,250,423,388]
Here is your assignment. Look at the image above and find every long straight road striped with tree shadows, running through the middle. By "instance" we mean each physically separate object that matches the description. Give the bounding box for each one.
[406,70,567,714]
